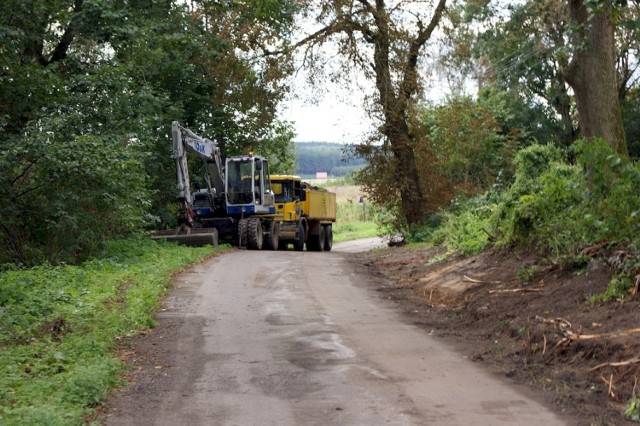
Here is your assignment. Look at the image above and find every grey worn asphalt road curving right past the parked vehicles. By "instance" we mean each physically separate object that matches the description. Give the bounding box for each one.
[102,240,565,426]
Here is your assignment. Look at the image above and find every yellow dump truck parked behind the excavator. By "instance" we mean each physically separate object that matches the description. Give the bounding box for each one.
[271,175,336,251]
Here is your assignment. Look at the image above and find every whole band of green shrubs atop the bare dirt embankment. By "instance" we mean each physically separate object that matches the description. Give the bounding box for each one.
[409,140,640,287]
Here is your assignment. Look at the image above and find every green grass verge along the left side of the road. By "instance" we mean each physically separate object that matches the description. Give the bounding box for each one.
[0,240,218,425]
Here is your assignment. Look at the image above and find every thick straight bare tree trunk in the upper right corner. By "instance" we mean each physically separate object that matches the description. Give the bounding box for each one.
[565,0,628,156]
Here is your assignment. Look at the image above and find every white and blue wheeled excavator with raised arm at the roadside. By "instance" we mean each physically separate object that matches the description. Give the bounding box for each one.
[152,121,281,250]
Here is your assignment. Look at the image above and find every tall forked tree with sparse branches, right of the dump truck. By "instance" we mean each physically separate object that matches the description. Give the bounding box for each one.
[298,0,446,224]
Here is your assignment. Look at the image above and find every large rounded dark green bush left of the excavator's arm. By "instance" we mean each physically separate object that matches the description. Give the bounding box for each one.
[0,67,157,266]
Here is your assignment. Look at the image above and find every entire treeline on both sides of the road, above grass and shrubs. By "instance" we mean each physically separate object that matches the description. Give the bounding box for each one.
[0,0,640,265]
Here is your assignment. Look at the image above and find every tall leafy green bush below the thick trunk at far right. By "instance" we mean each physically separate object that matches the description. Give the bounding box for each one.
[494,140,640,256]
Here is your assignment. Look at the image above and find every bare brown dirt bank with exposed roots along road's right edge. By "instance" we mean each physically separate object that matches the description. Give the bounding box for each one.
[351,247,640,425]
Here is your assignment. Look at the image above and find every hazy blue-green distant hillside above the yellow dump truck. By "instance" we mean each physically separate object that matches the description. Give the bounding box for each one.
[295,142,366,177]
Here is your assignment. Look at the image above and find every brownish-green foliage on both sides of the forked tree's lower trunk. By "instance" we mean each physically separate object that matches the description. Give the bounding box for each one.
[357,96,516,232]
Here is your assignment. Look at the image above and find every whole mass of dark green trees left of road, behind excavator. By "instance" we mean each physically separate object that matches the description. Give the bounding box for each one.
[0,0,294,265]
